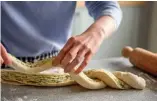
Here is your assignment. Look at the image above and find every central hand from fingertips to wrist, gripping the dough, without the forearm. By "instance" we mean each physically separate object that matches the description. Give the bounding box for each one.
[54,30,104,74]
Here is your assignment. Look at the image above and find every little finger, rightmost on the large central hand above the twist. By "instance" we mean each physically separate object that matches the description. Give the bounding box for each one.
[75,53,92,74]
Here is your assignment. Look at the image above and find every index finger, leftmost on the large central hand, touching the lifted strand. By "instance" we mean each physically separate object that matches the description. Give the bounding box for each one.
[53,38,73,65]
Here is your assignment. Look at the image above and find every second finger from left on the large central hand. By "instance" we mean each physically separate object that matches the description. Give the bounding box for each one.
[61,42,81,68]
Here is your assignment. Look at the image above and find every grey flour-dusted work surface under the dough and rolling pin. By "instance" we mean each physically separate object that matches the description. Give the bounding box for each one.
[1,58,157,101]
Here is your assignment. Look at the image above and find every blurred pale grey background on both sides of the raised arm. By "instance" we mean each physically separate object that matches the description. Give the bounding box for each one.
[73,1,157,59]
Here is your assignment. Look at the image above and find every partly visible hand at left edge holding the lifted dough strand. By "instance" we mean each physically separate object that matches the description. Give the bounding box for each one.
[0,44,11,66]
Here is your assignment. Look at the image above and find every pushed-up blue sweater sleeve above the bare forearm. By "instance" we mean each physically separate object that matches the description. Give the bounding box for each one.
[85,1,122,29]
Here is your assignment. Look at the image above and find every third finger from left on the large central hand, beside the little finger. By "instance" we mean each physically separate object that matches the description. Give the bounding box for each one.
[64,46,88,72]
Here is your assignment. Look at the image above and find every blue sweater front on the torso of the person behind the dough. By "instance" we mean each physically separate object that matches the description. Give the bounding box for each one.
[1,1,76,57]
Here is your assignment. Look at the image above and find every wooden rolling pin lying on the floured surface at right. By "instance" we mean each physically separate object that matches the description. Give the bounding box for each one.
[122,46,157,76]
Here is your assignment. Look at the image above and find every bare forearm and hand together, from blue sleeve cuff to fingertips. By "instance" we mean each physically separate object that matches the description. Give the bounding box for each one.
[54,16,115,74]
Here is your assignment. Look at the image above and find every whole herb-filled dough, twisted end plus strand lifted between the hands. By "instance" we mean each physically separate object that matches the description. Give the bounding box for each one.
[1,56,146,89]
